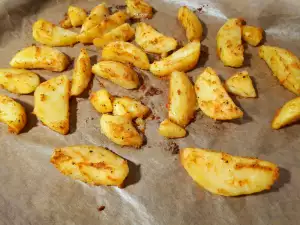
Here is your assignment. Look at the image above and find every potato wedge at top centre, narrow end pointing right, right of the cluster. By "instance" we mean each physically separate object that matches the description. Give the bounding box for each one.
[135,23,177,54]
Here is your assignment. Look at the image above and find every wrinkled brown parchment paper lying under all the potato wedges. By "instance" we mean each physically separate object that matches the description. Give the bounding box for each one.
[0,0,300,225]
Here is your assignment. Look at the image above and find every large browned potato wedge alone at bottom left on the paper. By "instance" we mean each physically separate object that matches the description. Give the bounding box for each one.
[50,145,129,186]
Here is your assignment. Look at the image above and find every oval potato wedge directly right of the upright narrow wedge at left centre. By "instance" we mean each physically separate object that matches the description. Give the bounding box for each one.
[92,61,140,89]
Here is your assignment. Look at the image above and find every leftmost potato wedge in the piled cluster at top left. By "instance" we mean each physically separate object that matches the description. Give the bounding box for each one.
[32,19,78,46]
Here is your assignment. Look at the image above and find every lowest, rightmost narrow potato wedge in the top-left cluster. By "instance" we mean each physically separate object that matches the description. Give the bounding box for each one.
[93,23,135,48]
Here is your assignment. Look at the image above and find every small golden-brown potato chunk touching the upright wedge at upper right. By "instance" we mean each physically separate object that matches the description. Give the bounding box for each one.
[242,25,264,46]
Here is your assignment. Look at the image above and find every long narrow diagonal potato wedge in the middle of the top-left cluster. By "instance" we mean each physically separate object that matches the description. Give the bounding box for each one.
[78,11,128,44]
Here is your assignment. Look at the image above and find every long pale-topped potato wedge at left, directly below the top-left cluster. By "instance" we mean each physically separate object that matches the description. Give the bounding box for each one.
[9,46,70,72]
